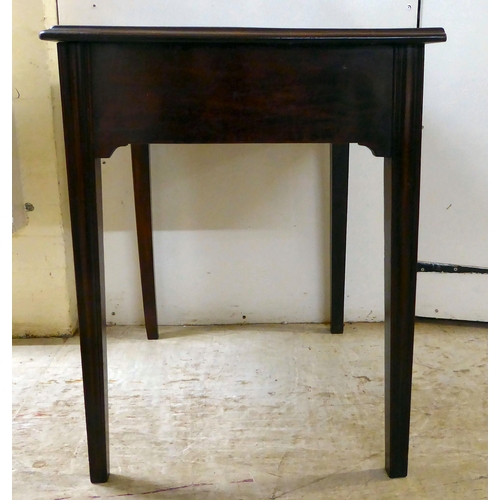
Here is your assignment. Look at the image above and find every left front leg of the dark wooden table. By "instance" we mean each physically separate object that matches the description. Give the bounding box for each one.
[58,44,109,483]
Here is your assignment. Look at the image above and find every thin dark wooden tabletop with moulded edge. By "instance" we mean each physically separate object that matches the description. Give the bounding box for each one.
[40,25,446,45]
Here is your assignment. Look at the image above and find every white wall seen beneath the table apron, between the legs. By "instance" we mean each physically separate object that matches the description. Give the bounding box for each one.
[103,144,383,324]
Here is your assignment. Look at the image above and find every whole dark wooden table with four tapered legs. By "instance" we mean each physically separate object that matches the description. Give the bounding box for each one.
[40,26,446,483]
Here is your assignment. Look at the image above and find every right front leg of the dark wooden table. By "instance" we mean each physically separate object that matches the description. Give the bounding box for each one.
[384,46,424,477]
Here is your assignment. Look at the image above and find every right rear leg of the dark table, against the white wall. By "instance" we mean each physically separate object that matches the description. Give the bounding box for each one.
[330,144,349,333]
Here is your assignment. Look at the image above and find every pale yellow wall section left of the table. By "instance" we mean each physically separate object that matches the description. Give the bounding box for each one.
[12,0,77,337]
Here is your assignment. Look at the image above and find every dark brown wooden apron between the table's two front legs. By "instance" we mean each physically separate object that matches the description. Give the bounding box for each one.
[92,42,393,157]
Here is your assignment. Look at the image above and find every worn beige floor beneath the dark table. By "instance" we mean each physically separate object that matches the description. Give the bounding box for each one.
[12,323,487,500]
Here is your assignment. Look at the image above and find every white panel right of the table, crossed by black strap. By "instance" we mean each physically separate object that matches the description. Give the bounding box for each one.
[417,0,488,321]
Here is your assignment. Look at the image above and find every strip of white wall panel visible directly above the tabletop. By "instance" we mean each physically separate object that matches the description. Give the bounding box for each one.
[58,0,418,28]
